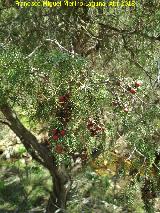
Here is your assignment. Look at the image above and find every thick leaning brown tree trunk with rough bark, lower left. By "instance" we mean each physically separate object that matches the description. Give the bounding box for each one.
[0,104,69,213]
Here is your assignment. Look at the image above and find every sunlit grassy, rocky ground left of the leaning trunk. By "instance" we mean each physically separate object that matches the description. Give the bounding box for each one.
[0,125,51,213]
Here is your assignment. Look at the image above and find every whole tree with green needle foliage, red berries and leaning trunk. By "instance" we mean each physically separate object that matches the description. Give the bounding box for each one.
[0,1,160,212]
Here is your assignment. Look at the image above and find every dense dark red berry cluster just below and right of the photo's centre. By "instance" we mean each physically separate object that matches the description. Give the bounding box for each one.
[87,118,104,136]
